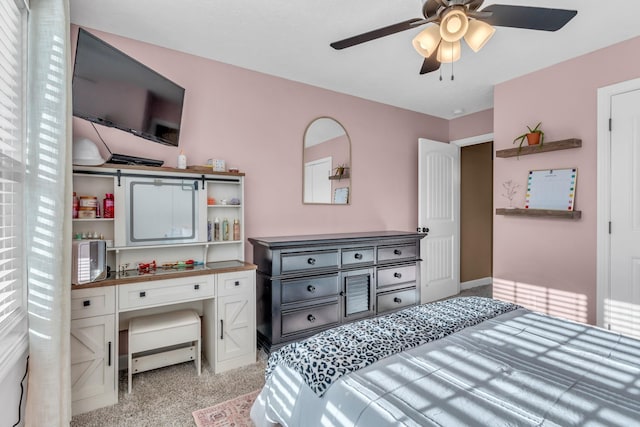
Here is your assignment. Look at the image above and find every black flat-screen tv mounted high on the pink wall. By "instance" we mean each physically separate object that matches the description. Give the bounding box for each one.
[72,28,184,147]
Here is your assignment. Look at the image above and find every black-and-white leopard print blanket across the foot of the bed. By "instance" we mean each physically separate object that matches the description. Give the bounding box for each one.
[265,297,520,396]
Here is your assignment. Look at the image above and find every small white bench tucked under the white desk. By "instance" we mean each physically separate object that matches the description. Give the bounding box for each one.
[128,310,201,393]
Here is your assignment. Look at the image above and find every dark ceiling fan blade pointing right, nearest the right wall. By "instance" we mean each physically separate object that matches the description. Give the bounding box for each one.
[482,4,578,31]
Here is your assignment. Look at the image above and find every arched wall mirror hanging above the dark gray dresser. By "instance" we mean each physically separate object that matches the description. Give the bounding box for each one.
[302,117,351,205]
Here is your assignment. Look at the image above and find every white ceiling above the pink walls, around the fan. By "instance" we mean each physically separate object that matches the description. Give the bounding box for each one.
[70,0,640,119]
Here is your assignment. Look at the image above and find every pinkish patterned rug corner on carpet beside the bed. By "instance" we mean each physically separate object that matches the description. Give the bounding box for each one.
[193,390,260,427]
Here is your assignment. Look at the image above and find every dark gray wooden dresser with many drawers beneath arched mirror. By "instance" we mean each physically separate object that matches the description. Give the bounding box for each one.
[249,231,425,352]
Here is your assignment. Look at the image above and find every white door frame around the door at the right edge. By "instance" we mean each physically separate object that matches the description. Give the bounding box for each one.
[596,78,640,328]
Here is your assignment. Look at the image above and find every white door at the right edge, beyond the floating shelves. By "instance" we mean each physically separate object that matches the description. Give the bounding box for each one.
[604,90,640,338]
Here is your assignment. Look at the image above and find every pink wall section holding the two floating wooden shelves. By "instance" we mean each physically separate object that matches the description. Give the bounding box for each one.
[493,38,640,323]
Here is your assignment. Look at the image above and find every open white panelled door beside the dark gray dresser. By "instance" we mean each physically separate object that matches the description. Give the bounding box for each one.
[418,138,460,303]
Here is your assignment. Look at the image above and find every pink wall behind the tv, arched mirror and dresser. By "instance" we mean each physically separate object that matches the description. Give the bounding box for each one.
[71,26,449,261]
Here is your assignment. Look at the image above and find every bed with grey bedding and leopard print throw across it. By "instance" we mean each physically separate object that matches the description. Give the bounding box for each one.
[251,297,640,427]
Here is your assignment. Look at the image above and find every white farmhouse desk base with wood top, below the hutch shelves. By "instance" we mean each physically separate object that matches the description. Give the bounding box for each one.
[71,261,256,415]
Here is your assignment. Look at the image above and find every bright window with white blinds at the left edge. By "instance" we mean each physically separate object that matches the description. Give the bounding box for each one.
[0,0,27,380]
